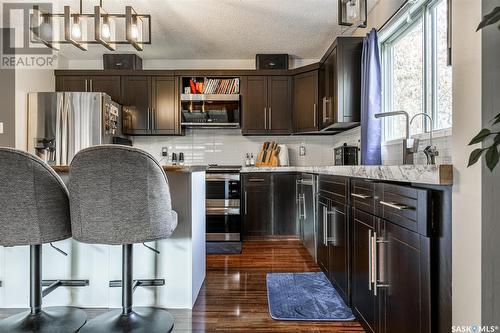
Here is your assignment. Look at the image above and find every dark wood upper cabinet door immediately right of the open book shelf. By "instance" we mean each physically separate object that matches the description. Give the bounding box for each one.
[241,76,267,134]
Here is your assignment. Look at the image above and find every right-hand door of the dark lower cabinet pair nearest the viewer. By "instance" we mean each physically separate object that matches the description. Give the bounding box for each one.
[377,220,433,333]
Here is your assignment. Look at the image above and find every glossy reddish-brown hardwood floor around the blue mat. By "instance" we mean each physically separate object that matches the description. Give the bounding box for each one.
[0,240,364,333]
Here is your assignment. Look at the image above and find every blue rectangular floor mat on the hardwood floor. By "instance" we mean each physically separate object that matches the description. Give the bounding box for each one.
[267,272,354,321]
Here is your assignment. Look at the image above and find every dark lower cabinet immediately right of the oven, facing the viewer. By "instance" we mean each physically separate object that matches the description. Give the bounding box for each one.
[242,173,299,237]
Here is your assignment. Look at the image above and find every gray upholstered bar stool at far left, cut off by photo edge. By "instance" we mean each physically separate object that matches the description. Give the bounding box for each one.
[0,148,87,333]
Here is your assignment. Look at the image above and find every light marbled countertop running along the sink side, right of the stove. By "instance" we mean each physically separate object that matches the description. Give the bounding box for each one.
[241,164,453,185]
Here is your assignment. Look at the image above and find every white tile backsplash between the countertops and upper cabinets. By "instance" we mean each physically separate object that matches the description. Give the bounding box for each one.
[132,127,452,166]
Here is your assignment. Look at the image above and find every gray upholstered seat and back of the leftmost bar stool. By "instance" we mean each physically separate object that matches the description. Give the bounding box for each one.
[0,148,71,246]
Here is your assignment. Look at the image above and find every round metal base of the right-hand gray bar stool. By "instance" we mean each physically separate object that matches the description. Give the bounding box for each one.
[80,307,174,333]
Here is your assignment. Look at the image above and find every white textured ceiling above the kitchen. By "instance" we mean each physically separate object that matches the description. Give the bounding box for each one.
[29,0,379,60]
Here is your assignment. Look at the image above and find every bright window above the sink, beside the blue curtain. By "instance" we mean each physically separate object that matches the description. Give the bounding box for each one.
[380,0,452,140]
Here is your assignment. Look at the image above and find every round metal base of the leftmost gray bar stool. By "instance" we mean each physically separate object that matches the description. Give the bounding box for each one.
[0,306,87,333]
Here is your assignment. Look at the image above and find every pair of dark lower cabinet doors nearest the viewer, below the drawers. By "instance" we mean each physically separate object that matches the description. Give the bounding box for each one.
[352,209,434,333]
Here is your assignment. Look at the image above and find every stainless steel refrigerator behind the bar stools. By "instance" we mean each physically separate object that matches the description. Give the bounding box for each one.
[28,92,122,165]
